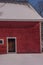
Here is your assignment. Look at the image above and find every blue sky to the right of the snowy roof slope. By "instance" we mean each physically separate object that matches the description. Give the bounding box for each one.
[28,0,43,17]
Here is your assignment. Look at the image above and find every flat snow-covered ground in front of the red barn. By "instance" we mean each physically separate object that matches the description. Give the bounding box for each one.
[0,53,43,65]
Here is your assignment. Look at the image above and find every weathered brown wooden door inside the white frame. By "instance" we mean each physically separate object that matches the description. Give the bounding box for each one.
[7,38,16,53]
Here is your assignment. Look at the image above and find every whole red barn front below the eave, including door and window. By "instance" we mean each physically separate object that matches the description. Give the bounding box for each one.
[0,21,41,54]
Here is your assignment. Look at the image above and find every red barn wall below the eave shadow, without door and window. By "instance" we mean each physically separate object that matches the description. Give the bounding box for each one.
[0,22,40,54]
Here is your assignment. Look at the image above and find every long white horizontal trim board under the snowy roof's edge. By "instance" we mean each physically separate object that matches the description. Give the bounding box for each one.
[0,18,43,22]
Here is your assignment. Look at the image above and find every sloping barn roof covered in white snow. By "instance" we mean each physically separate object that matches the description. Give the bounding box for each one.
[0,3,42,20]
